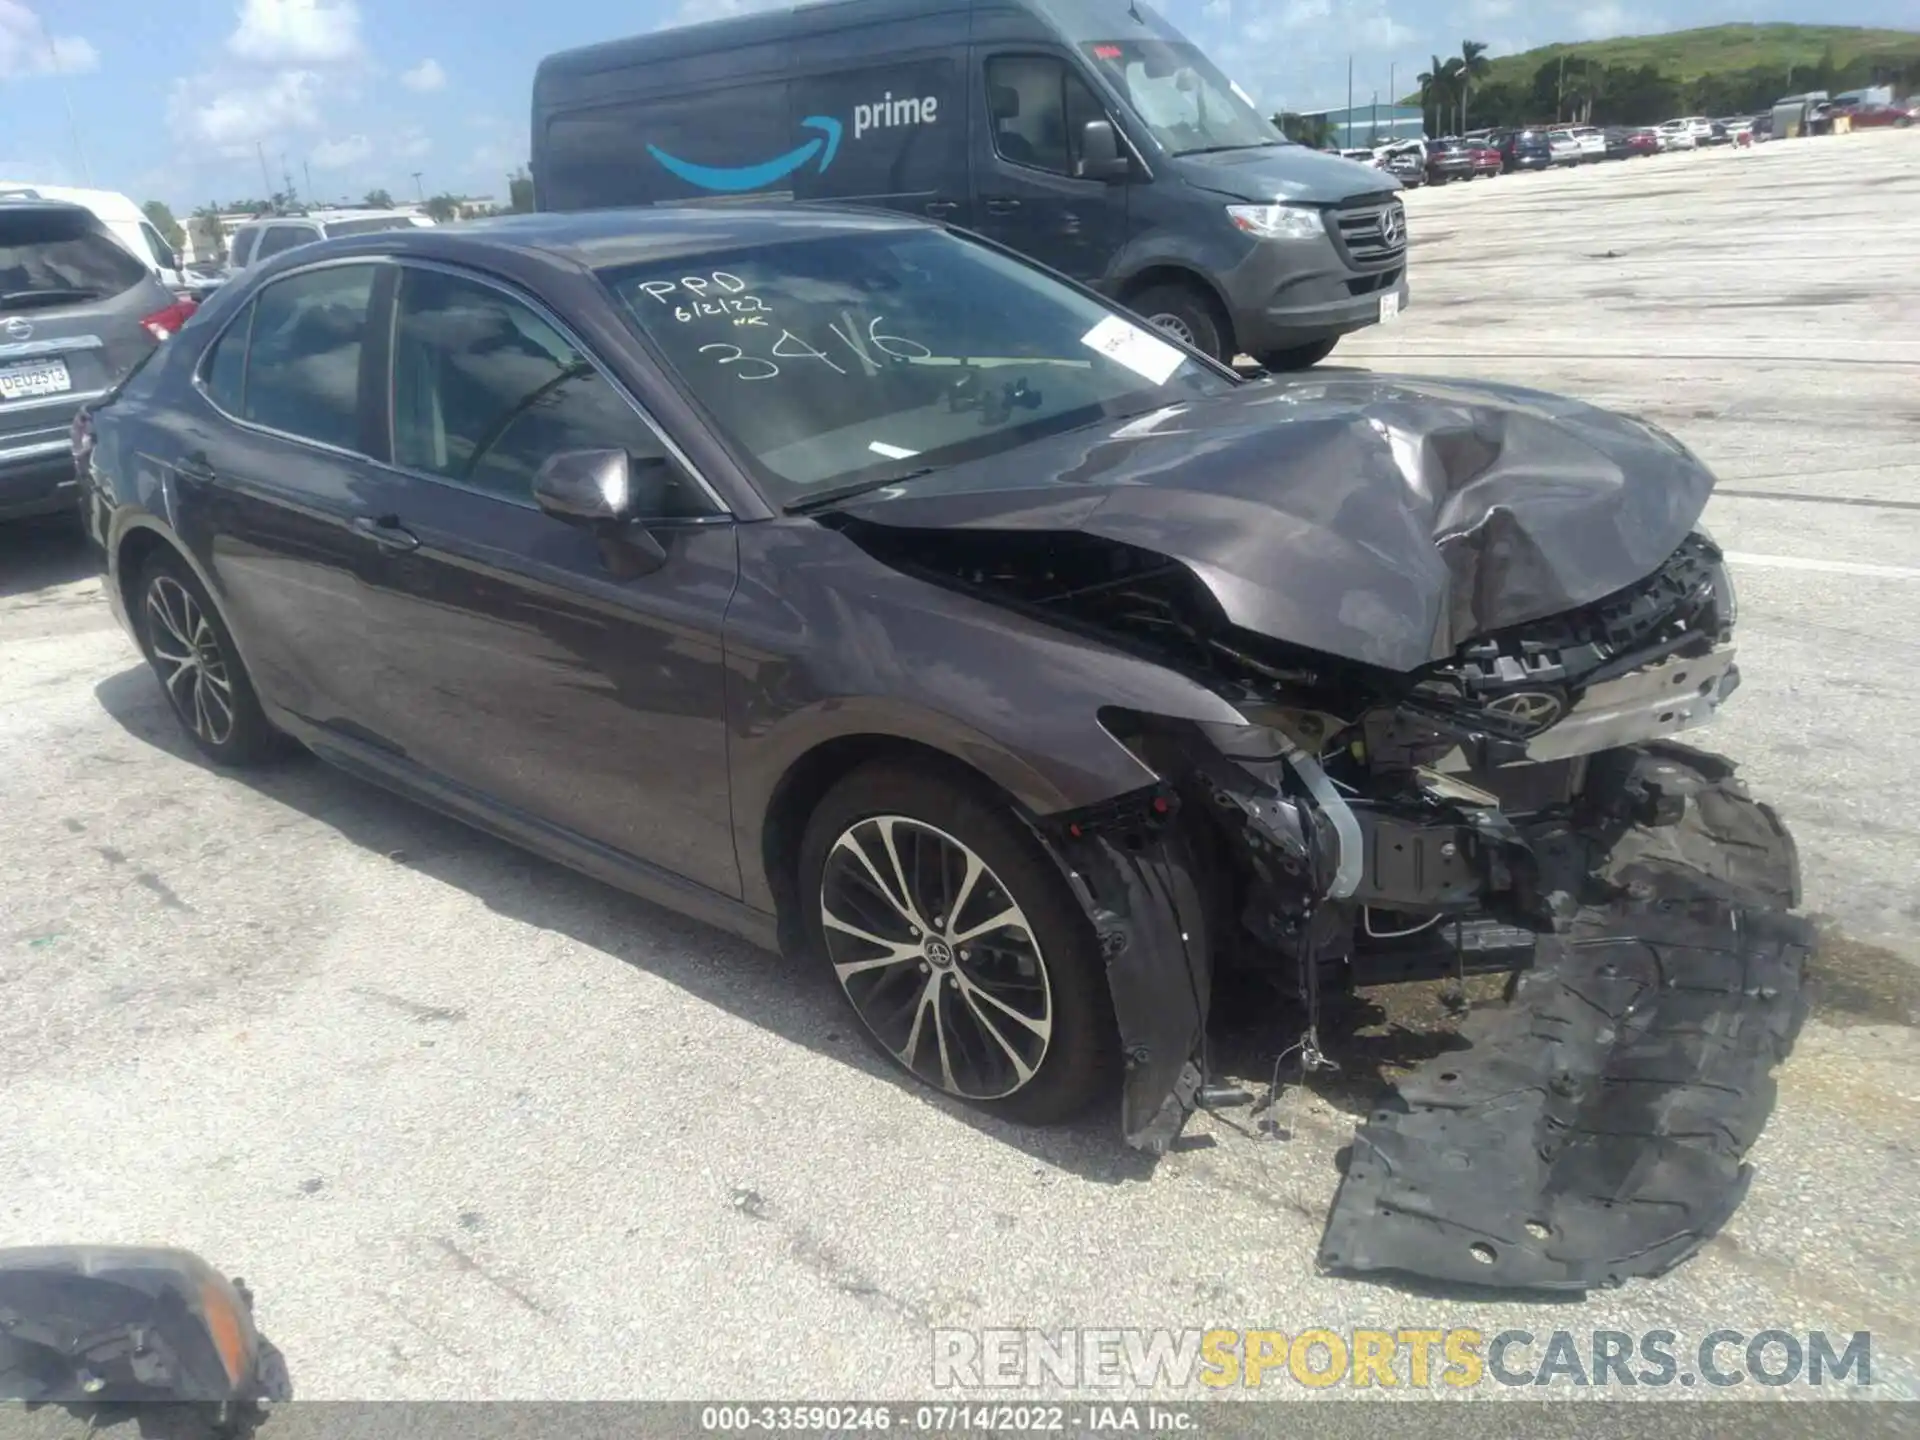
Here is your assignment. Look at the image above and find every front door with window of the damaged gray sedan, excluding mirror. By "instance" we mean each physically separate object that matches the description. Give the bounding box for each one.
[355,263,739,897]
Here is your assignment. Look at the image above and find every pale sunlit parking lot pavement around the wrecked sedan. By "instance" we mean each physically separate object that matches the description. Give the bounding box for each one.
[0,132,1920,1400]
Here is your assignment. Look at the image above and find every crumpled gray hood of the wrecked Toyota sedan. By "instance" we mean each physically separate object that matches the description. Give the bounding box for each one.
[839,374,1713,672]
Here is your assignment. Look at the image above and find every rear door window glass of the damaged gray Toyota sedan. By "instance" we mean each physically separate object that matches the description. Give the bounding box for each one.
[240,265,374,449]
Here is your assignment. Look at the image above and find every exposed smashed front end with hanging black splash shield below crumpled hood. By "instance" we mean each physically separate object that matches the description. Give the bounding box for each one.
[839,516,1812,1290]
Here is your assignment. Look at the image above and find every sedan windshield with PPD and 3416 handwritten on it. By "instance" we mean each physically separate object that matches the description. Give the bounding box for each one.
[601,230,1235,505]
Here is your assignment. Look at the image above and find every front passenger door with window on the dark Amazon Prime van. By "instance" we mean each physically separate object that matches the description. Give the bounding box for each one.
[972,46,1131,282]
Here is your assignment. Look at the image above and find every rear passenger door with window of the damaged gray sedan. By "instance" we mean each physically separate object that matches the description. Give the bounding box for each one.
[159,261,392,726]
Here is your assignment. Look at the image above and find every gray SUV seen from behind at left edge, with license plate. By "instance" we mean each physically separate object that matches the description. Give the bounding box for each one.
[0,200,194,520]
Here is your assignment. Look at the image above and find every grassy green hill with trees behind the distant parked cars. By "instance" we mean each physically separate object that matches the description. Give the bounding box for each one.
[1404,25,1920,129]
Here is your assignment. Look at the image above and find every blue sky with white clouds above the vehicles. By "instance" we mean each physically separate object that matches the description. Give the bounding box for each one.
[0,0,1920,209]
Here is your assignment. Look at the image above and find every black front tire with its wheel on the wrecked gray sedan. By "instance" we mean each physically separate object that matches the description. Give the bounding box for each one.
[799,760,1119,1125]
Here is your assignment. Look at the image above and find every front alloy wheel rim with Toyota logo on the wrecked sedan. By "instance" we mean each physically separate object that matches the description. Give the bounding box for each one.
[820,814,1054,1100]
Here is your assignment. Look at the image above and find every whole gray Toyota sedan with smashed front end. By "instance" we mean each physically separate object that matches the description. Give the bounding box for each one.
[75,205,1812,1288]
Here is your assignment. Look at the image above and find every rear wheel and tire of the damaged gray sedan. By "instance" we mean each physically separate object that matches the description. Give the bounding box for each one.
[132,551,292,766]
